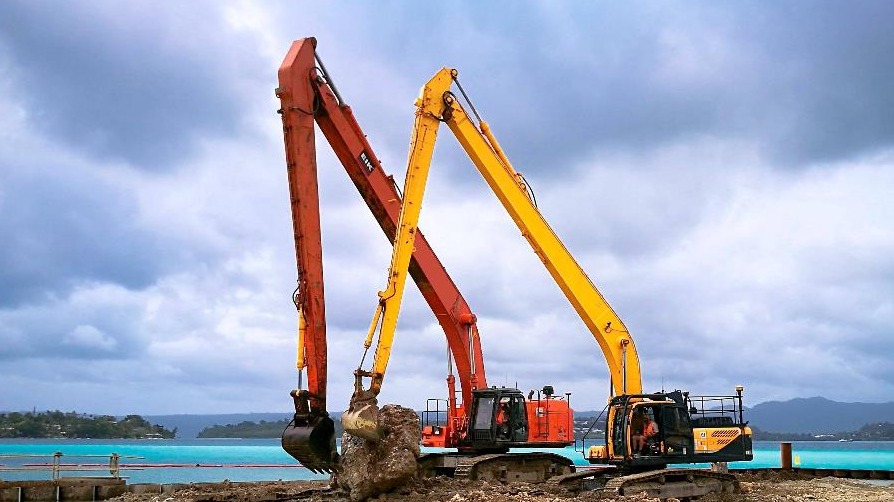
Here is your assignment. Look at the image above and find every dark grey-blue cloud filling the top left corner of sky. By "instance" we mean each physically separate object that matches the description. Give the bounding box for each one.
[0,1,262,171]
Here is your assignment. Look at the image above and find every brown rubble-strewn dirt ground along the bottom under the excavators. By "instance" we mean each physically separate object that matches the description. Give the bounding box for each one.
[111,474,894,502]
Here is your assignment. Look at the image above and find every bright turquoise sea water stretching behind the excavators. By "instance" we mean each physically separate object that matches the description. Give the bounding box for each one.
[0,439,894,483]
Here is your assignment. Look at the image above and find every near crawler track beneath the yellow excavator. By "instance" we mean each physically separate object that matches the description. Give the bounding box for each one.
[602,469,739,500]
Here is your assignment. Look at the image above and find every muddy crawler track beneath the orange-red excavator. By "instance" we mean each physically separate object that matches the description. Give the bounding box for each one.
[453,453,574,483]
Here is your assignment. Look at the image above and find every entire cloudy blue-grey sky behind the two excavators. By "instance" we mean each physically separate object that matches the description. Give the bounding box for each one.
[0,1,894,414]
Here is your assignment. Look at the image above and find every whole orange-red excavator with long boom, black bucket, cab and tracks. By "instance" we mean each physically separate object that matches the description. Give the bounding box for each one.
[276,38,574,481]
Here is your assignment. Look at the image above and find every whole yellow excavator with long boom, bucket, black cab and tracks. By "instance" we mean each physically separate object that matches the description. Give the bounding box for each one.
[342,68,753,498]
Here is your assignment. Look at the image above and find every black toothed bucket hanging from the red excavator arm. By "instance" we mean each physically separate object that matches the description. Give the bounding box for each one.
[282,415,338,473]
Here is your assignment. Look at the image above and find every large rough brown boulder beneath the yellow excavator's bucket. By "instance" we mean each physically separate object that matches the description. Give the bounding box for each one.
[338,404,422,501]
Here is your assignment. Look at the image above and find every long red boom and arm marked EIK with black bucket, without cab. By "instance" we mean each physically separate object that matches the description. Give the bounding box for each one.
[276,38,487,471]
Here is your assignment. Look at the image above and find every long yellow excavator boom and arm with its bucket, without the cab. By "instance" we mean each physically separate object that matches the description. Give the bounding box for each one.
[342,68,642,439]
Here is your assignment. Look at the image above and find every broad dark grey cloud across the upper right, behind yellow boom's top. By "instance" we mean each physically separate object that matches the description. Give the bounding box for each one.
[328,2,894,179]
